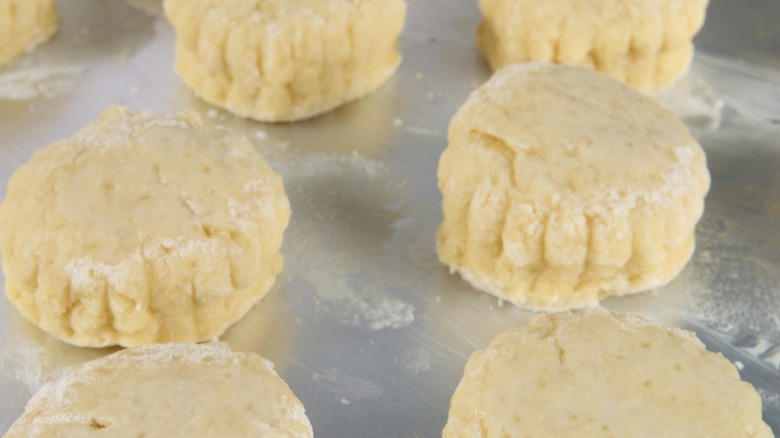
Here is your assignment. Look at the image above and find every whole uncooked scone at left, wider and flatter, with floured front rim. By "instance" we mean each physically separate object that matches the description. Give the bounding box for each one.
[0,107,290,347]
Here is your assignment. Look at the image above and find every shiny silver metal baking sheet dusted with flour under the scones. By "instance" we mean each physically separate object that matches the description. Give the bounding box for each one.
[0,0,780,437]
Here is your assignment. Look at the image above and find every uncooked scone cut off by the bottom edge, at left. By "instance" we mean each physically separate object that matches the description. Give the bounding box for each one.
[5,344,312,438]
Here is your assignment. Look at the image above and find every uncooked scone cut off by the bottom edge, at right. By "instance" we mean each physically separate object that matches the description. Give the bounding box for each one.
[443,311,773,438]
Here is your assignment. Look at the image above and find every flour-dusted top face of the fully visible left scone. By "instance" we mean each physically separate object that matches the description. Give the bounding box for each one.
[9,107,285,264]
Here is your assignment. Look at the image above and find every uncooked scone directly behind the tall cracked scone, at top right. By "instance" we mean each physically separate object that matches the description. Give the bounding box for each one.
[477,0,708,92]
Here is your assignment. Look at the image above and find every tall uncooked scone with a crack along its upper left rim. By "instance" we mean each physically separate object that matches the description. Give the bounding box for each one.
[438,64,709,310]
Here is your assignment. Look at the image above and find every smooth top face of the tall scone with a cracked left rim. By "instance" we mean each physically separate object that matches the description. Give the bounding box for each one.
[450,64,709,217]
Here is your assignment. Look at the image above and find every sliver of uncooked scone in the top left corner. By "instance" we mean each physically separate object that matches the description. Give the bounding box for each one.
[0,0,58,65]
